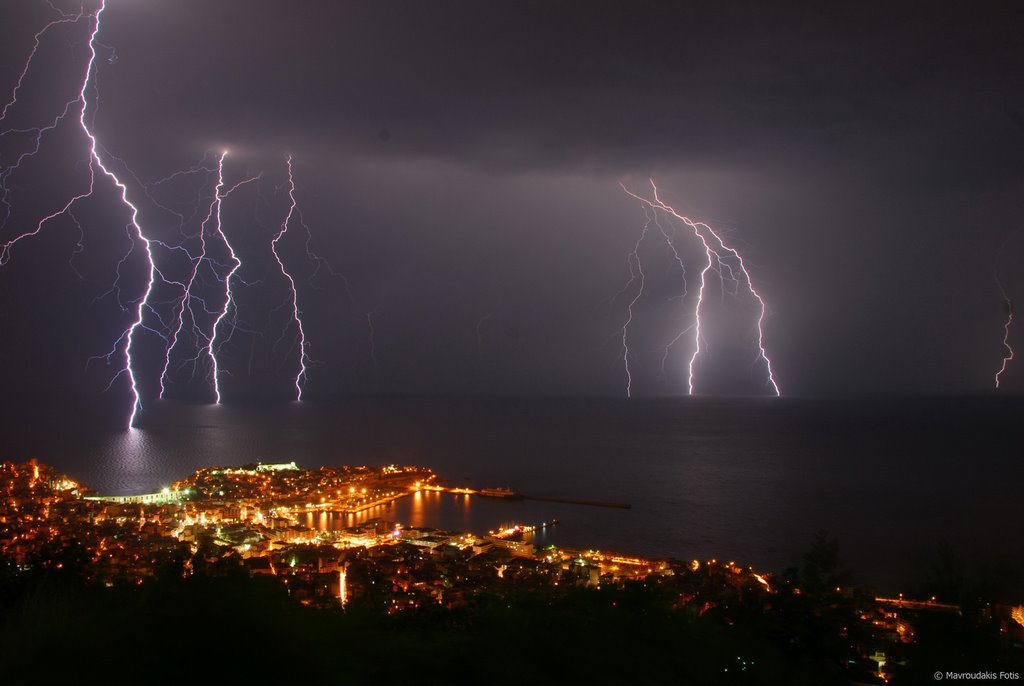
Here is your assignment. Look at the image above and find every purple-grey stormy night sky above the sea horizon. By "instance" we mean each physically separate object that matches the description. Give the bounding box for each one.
[0,0,1024,413]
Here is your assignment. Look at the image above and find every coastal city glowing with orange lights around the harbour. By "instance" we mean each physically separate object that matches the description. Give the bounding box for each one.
[0,462,1024,683]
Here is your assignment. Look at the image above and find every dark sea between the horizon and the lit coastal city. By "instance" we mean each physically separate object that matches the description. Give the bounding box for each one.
[0,395,1024,593]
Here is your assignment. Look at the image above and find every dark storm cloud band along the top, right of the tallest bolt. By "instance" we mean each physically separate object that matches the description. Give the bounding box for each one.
[97,2,1024,181]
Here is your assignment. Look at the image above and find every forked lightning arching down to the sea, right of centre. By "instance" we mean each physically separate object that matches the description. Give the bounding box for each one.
[620,179,780,396]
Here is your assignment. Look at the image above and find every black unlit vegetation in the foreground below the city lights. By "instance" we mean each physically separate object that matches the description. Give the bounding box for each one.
[0,552,1024,685]
